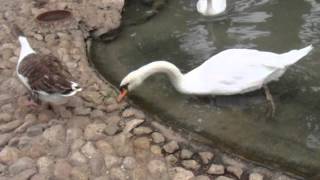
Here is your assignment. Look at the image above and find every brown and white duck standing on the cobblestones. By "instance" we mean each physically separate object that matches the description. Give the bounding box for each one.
[13,25,82,105]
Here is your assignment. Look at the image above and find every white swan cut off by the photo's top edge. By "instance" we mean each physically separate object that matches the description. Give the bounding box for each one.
[197,0,227,16]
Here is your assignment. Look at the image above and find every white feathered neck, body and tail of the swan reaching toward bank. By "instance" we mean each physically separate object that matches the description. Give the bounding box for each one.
[121,45,313,95]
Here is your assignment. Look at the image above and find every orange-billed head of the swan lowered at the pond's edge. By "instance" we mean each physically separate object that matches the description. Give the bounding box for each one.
[117,71,143,102]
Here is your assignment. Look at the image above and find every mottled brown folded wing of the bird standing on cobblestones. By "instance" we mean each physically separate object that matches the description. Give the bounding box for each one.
[18,54,72,94]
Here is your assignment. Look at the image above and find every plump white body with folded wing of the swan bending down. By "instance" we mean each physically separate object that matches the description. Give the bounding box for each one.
[183,49,310,95]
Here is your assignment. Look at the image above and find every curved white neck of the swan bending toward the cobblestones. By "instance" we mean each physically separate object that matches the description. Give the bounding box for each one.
[137,61,183,91]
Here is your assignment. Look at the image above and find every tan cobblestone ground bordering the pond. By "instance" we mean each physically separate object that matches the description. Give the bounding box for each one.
[0,0,304,180]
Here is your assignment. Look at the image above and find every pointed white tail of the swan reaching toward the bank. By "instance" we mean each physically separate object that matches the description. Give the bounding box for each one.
[281,45,313,66]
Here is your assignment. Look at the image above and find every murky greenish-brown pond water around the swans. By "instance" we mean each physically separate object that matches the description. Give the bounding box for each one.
[91,0,320,175]
